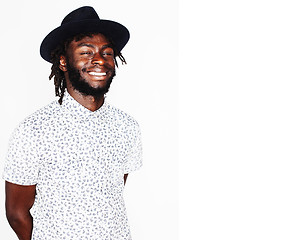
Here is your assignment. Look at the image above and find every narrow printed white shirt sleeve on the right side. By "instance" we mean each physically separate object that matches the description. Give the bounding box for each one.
[124,123,143,173]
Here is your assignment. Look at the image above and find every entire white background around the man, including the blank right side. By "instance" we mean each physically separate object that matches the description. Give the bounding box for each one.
[0,0,296,240]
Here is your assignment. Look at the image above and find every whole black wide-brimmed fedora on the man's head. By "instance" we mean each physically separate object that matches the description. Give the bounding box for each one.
[40,6,130,62]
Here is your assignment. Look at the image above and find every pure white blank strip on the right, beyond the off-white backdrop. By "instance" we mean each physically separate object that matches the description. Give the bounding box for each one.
[179,0,296,240]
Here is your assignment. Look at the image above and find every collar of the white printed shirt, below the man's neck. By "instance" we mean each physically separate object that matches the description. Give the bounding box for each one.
[62,90,109,117]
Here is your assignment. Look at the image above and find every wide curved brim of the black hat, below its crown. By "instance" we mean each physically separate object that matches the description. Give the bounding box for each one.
[40,19,130,62]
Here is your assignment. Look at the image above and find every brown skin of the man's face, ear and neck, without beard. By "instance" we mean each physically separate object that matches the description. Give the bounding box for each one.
[60,34,115,111]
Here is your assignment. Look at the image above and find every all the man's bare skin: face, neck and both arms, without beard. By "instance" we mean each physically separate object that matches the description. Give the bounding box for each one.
[5,34,128,240]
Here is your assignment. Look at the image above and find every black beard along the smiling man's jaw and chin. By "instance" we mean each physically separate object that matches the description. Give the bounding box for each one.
[67,61,116,98]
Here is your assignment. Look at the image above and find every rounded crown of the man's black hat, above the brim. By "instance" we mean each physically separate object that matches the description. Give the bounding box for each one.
[61,7,100,25]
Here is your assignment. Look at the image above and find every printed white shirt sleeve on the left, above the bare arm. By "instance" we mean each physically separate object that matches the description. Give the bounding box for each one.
[3,123,39,185]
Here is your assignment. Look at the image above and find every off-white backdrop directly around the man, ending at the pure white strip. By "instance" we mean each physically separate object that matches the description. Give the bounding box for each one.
[0,0,178,240]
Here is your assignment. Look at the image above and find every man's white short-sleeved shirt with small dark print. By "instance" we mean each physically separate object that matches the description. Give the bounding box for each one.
[3,92,142,240]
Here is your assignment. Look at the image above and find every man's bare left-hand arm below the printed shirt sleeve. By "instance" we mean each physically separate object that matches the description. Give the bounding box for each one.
[5,181,36,240]
